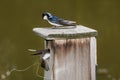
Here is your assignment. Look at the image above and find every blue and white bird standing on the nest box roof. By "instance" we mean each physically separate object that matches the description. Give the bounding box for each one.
[42,12,76,27]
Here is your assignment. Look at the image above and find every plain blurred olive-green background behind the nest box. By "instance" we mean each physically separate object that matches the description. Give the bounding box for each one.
[0,0,120,80]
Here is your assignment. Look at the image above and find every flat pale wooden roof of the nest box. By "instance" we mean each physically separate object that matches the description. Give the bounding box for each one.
[33,25,97,40]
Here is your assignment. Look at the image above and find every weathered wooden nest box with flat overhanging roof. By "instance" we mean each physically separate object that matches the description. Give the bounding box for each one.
[33,25,97,80]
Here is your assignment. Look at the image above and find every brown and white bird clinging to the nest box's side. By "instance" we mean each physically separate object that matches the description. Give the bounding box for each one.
[28,49,50,71]
